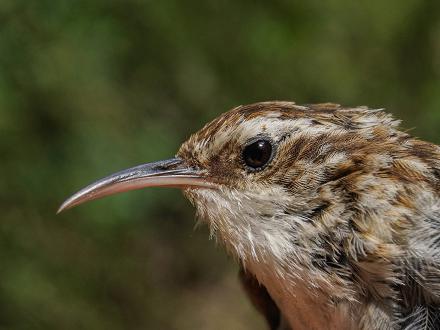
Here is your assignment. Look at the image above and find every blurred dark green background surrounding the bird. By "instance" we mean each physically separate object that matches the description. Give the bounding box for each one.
[0,0,440,330]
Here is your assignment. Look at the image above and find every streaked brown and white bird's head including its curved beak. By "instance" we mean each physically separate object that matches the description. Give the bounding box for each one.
[60,102,403,288]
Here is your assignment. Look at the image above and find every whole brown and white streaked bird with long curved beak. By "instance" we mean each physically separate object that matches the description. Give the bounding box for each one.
[59,101,440,330]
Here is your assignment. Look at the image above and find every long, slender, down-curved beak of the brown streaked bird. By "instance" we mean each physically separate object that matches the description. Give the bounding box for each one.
[57,158,213,213]
